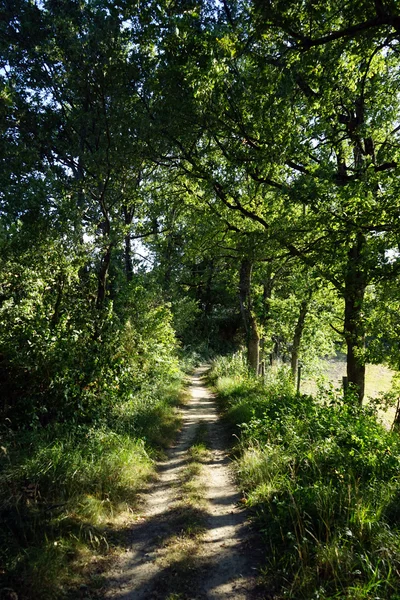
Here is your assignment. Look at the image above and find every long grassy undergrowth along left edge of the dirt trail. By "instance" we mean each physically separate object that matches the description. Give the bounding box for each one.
[0,374,182,600]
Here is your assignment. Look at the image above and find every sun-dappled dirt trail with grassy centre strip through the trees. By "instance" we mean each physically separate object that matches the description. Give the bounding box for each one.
[104,367,260,600]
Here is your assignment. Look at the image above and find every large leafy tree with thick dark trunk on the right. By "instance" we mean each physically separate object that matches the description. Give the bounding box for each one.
[151,2,398,401]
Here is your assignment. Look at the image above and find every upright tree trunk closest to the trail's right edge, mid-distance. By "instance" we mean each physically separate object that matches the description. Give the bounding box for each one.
[239,259,260,373]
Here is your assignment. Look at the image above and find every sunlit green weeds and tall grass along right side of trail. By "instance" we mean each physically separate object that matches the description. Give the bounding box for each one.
[209,355,400,600]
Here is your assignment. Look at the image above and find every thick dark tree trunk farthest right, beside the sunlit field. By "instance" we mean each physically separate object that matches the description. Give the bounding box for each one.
[344,234,367,404]
